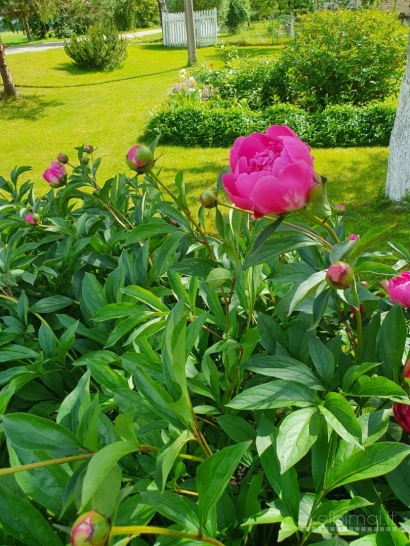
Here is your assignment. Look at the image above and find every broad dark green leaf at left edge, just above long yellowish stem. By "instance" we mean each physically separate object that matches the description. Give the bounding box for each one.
[3,413,86,457]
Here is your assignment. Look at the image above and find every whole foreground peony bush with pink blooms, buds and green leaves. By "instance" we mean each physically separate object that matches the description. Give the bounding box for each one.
[0,126,410,546]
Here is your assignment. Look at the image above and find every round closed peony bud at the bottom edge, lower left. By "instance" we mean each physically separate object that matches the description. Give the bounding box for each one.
[70,510,111,546]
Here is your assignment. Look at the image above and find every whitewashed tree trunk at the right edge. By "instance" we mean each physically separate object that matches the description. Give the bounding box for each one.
[386,35,410,202]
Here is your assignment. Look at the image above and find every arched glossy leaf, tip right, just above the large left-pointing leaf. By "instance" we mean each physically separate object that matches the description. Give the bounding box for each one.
[241,354,324,390]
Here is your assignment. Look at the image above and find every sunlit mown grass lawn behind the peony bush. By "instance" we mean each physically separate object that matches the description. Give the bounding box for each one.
[0,37,404,245]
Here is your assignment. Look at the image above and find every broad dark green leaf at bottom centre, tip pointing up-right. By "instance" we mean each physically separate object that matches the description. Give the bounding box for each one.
[196,442,251,527]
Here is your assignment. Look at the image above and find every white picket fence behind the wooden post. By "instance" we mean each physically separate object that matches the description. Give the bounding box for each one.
[162,8,218,47]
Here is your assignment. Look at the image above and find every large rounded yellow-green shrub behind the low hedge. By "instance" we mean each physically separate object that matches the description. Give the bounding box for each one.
[276,9,408,111]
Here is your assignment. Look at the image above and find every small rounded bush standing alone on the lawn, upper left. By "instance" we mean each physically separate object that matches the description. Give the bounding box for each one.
[64,21,127,70]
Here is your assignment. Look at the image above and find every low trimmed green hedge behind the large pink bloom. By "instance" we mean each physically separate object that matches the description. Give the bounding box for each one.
[145,103,396,148]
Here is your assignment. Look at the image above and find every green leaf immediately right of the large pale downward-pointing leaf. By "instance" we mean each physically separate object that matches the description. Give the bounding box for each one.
[319,392,363,447]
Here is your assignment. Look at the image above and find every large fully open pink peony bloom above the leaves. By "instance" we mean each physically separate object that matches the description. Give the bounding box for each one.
[222,125,315,218]
